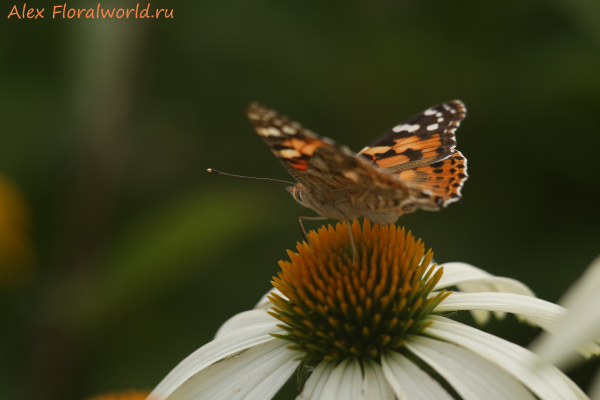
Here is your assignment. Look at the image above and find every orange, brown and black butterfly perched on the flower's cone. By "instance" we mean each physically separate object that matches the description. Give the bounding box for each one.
[246,100,468,224]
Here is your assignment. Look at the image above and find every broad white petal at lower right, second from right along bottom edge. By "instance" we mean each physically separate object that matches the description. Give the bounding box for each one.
[406,336,535,400]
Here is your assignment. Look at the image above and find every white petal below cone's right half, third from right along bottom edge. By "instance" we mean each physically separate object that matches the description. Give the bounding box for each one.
[381,351,453,400]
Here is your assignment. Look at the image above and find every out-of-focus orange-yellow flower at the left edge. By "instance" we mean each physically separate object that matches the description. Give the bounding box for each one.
[0,174,34,285]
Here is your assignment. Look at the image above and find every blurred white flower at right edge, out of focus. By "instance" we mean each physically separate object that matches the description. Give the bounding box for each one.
[531,257,600,399]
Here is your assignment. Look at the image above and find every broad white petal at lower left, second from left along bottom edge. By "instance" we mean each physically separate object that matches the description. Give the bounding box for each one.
[169,340,300,400]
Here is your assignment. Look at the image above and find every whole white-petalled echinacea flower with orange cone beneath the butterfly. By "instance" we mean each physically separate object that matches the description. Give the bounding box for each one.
[150,220,587,400]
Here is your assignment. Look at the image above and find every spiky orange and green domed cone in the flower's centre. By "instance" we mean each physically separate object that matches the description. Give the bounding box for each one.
[269,219,450,364]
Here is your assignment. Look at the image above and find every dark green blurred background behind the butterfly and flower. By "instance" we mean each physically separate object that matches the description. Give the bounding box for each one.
[0,0,600,400]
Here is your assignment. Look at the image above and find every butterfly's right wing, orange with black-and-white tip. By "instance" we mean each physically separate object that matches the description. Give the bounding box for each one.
[358,100,468,208]
